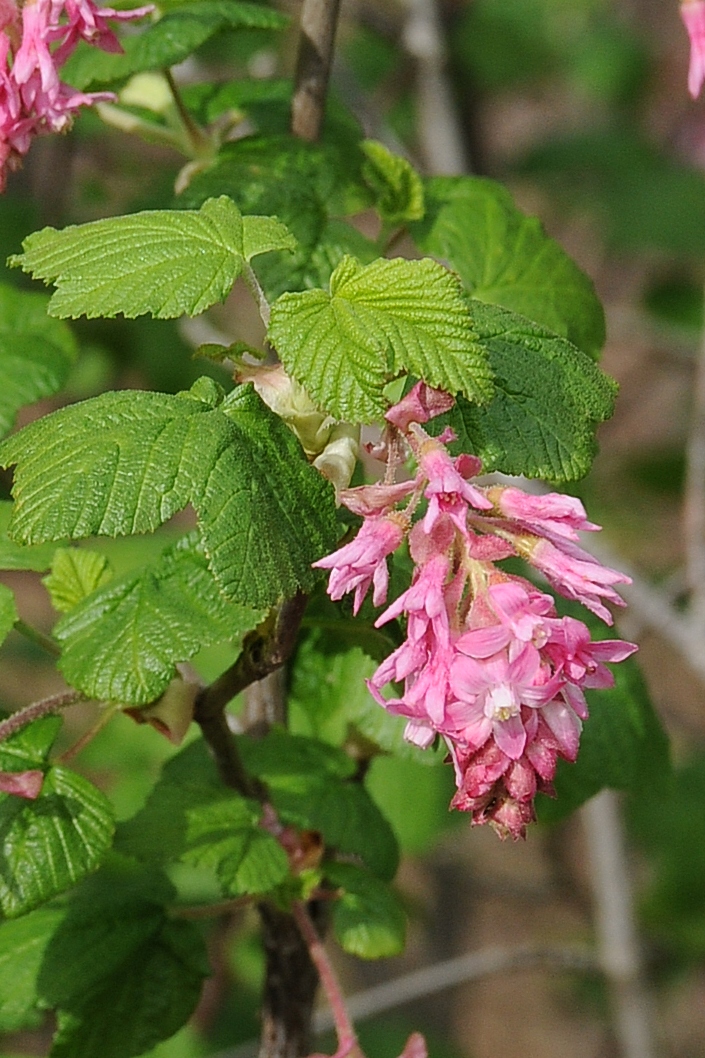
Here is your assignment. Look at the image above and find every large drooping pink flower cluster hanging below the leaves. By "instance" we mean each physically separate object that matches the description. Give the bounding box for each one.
[315,383,636,838]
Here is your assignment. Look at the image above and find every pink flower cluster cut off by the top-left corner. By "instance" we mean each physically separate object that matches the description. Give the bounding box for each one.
[0,0,153,190]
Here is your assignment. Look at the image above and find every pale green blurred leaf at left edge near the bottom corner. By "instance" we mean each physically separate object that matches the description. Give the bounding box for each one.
[0,908,64,1033]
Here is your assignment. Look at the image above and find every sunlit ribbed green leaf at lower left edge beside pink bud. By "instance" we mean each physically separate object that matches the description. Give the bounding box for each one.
[0,717,113,918]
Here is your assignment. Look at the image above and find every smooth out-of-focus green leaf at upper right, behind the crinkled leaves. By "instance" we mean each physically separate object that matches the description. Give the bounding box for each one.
[412,177,604,357]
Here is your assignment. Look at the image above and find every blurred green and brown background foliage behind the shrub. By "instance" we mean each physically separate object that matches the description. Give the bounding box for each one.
[0,0,705,1058]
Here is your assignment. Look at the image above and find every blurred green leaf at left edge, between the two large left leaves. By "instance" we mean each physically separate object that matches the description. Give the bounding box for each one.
[0,284,76,436]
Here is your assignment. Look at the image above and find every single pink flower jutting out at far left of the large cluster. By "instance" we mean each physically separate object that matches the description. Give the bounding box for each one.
[313,512,408,614]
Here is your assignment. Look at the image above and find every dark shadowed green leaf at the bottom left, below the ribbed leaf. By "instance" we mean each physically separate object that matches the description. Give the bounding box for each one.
[38,871,209,1058]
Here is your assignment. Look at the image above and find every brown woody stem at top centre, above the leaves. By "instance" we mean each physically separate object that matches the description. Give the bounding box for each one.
[291,0,340,143]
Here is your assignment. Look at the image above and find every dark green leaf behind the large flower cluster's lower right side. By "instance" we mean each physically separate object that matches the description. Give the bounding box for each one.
[538,630,670,822]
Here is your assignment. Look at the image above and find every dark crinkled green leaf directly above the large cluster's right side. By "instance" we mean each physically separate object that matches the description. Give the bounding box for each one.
[433,302,617,481]
